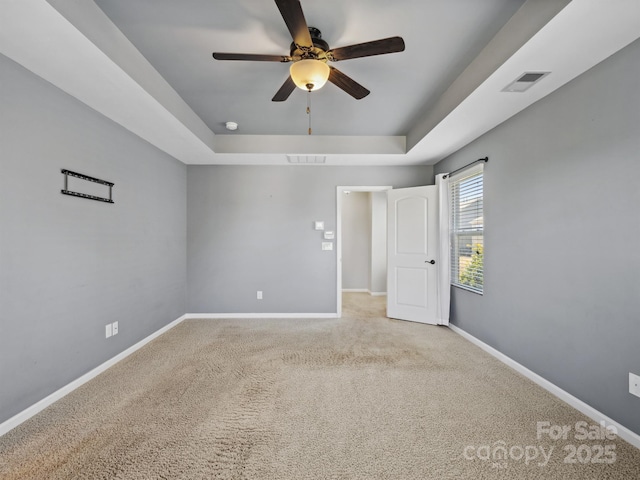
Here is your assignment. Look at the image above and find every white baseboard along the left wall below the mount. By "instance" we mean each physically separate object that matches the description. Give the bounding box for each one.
[0,315,186,436]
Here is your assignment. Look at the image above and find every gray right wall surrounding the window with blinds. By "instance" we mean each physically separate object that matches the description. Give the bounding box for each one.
[436,37,640,434]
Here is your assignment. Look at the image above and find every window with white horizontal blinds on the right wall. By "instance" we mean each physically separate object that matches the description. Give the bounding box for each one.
[449,165,484,294]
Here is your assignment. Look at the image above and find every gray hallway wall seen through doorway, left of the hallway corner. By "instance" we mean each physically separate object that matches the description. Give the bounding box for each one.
[341,192,371,290]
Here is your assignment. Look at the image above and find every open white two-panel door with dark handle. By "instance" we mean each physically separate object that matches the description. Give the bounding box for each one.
[387,186,439,325]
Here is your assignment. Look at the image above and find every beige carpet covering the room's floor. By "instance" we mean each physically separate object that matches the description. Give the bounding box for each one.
[0,294,640,480]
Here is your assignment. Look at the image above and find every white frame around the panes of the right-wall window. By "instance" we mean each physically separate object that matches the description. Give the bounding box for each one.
[449,163,484,295]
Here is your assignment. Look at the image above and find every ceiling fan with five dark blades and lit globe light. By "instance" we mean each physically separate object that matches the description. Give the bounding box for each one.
[213,0,404,102]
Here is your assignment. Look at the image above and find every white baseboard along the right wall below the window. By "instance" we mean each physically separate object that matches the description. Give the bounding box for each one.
[449,324,640,448]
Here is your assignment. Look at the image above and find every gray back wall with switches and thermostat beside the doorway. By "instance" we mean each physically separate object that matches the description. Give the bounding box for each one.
[187,165,433,313]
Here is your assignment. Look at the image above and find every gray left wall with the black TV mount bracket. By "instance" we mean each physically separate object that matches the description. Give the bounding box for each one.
[0,55,186,422]
